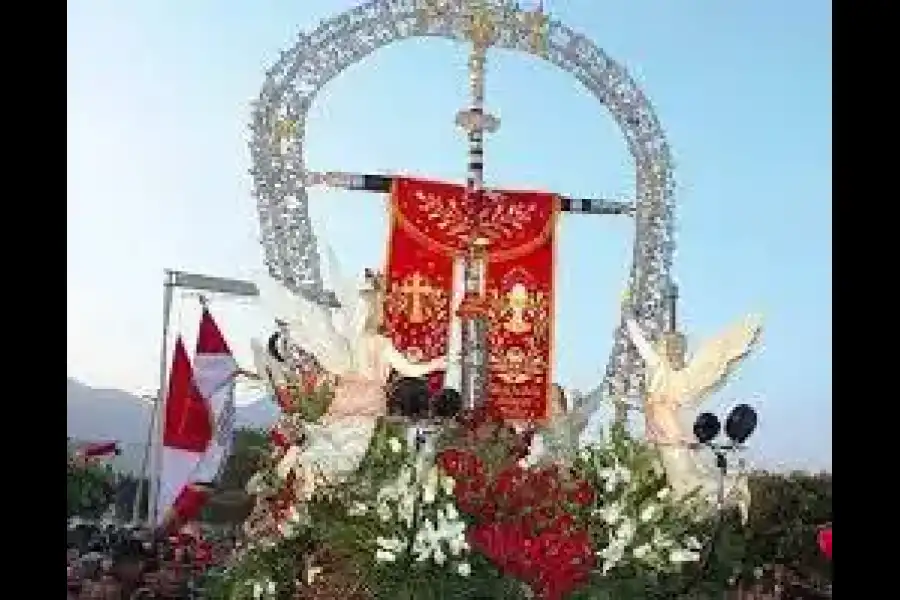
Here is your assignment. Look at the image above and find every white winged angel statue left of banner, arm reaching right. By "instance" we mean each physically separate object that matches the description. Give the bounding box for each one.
[255,255,446,497]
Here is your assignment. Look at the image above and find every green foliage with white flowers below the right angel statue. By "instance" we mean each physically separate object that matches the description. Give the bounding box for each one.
[572,428,731,600]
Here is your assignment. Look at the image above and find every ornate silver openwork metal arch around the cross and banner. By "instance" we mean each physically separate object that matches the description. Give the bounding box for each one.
[250,0,674,404]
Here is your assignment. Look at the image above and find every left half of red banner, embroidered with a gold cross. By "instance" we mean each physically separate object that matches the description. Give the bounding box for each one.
[384,179,465,391]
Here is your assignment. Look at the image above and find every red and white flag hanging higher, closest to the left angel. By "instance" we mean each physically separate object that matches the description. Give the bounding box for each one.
[194,307,238,484]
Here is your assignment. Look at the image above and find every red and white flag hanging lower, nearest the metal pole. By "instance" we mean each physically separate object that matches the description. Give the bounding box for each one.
[156,337,214,521]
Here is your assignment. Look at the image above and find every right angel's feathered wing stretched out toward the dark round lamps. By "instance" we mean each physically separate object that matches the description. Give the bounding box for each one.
[673,315,762,406]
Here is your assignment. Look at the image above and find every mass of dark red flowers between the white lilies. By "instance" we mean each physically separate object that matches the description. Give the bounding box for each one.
[438,409,595,600]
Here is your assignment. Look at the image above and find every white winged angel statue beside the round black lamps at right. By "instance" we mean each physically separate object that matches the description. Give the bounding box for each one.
[625,315,762,515]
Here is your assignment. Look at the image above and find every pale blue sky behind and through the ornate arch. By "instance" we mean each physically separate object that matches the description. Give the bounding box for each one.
[66,0,831,468]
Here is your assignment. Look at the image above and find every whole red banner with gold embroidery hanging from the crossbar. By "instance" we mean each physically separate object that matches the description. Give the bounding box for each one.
[385,179,558,420]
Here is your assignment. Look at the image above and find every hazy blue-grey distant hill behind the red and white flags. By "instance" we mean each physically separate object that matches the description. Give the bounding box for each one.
[66,377,278,473]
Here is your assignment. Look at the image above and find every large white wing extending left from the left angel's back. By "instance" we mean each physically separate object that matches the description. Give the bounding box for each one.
[256,275,353,375]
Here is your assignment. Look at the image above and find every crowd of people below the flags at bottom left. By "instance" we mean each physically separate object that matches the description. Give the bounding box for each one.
[66,522,235,600]
